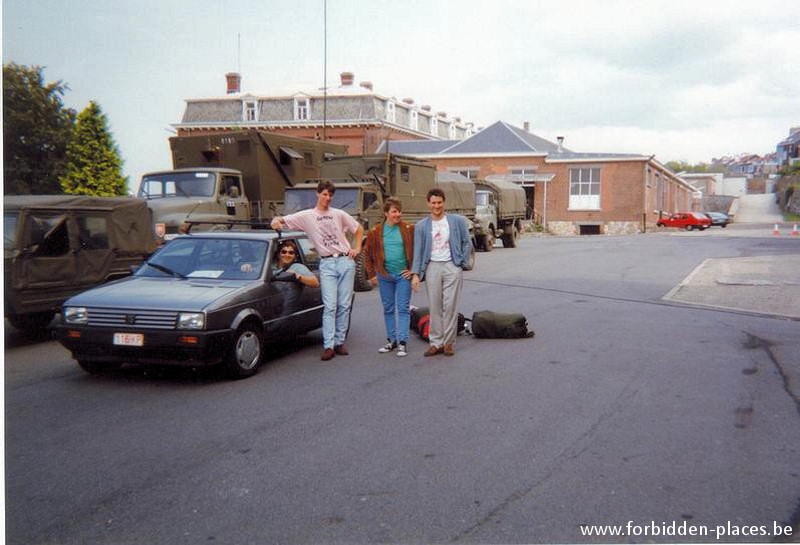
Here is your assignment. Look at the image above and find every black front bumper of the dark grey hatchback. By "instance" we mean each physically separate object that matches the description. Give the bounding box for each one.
[56,324,233,367]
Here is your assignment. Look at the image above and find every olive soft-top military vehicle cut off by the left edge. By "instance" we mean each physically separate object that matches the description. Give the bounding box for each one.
[3,195,156,331]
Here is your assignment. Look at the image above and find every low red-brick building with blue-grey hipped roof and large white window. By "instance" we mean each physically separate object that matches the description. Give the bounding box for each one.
[378,121,695,235]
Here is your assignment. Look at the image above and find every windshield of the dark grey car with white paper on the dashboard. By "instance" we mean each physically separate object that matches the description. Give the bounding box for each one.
[141,237,268,280]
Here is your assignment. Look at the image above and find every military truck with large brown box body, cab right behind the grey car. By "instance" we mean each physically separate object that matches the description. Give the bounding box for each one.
[138,130,347,241]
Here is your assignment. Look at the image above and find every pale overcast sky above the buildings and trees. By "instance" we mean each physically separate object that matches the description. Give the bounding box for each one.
[2,0,800,191]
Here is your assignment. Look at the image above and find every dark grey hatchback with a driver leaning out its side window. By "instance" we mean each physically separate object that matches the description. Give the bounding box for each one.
[57,230,322,378]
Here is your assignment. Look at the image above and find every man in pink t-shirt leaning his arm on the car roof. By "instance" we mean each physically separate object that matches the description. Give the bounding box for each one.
[272,180,364,361]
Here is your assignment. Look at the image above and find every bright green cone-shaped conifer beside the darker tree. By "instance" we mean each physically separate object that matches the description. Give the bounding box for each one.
[61,101,128,197]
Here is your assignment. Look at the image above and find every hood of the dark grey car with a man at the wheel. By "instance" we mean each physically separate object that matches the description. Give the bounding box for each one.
[64,277,252,311]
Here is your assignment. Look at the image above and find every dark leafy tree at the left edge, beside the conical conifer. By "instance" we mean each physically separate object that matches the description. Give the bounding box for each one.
[3,63,75,195]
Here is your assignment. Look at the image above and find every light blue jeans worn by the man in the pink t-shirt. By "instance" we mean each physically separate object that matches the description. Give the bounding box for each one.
[319,257,356,348]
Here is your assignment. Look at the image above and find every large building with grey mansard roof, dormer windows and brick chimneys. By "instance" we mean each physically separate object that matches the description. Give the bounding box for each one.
[173,72,475,155]
